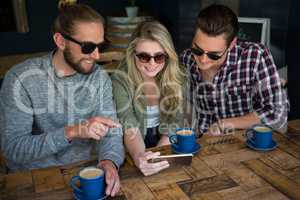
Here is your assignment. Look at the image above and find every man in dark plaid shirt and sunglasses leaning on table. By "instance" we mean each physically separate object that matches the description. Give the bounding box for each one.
[180,5,289,135]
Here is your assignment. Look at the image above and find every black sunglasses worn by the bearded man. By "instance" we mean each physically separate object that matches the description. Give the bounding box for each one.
[61,33,110,54]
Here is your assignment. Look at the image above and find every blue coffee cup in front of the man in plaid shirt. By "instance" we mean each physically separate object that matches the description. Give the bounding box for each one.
[246,124,273,148]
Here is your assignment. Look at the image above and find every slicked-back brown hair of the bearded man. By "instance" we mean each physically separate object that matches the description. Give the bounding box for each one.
[52,4,104,35]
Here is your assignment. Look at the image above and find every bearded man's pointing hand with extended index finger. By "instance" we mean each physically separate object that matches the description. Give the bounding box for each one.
[65,116,121,141]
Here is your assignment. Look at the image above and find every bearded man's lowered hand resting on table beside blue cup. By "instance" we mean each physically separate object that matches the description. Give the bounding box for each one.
[99,160,121,197]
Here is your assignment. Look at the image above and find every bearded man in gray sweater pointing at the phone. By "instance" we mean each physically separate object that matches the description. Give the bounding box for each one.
[0,4,124,196]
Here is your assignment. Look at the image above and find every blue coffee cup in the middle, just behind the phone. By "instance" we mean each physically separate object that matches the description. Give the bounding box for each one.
[169,128,196,153]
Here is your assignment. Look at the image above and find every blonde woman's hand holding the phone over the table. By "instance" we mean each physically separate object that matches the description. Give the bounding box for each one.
[134,151,170,176]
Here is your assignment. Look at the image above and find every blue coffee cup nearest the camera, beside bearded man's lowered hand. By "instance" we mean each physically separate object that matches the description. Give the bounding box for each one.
[71,167,105,200]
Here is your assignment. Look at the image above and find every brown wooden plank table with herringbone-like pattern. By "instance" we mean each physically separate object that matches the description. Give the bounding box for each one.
[0,132,300,200]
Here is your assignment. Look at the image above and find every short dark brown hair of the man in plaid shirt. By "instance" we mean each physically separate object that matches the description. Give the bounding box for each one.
[197,4,239,45]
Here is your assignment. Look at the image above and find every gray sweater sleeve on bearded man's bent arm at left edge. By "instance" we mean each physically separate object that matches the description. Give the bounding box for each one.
[0,73,70,164]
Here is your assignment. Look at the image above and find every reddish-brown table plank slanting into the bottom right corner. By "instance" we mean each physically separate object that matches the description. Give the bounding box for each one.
[244,160,300,199]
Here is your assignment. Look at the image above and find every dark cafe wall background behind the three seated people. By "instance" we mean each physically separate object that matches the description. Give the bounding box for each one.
[0,0,300,120]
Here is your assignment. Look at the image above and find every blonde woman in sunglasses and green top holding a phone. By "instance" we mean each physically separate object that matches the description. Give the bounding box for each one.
[112,21,185,176]
